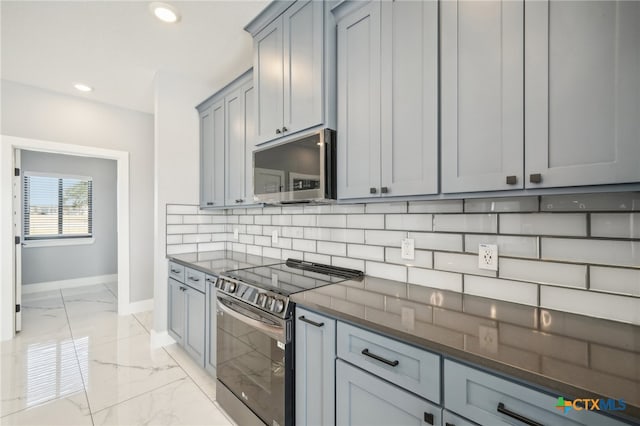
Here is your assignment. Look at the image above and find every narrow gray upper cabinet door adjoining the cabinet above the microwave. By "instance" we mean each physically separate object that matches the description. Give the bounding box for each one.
[225,79,255,206]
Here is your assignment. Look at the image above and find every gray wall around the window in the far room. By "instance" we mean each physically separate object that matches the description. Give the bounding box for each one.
[22,150,118,285]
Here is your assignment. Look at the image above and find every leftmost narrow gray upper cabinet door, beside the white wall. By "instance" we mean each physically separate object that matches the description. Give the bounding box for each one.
[198,99,225,208]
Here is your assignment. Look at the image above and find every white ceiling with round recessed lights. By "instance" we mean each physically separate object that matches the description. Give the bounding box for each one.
[0,0,269,113]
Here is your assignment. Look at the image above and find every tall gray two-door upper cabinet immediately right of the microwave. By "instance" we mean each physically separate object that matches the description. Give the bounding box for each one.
[335,1,438,199]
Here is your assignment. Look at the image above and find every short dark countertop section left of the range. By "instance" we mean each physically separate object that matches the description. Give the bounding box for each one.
[167,250,283,275]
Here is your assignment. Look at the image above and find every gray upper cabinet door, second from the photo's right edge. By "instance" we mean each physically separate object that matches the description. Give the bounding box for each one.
[440,0,529,192]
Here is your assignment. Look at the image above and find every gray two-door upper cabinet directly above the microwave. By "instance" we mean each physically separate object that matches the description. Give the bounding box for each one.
[245,0,335,143]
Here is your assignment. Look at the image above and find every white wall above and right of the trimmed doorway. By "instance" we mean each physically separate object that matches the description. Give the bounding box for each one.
[0,80,154,302]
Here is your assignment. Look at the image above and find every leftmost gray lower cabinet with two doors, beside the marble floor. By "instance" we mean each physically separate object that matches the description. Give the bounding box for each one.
[167,262,205,366]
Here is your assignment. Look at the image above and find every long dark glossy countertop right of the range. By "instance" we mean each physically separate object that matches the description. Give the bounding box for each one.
[292,277,640,423]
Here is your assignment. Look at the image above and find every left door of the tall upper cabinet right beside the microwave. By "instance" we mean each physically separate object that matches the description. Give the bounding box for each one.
[337,1,381,198]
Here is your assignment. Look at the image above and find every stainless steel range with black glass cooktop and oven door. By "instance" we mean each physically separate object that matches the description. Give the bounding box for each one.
[216,259,363,426]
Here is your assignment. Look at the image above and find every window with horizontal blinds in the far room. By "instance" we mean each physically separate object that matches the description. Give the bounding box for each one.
[23,172,93,240]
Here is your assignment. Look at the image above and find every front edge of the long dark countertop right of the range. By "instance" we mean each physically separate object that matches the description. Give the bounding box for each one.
[291,295,640,425]
